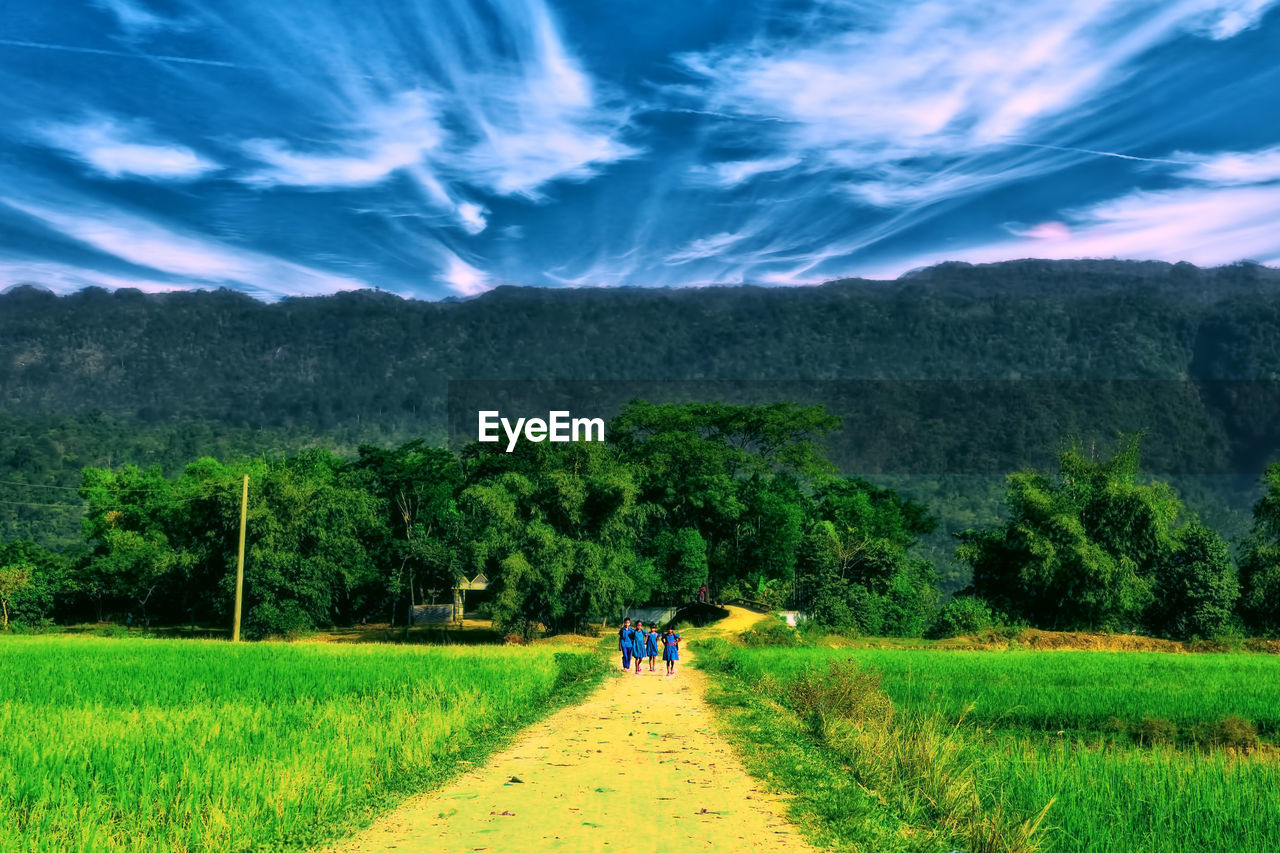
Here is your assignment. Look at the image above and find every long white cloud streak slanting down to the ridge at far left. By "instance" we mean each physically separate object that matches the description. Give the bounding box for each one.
[0,199,367,296]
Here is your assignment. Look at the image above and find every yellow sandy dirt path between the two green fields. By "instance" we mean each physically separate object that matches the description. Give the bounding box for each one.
[333,608,810,853]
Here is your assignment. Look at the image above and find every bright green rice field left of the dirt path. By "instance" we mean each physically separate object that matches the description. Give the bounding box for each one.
[0,637,599,853]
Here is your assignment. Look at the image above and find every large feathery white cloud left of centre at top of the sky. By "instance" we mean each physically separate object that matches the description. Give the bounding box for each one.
[222,0,639,222]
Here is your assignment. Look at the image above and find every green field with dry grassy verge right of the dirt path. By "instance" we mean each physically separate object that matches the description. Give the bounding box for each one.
[701,642,1280,853]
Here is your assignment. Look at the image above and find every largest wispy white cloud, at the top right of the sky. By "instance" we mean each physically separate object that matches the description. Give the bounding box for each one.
[671,0,1276,206]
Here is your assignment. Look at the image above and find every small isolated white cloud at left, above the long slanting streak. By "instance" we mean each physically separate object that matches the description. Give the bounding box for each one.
[36,115,221,181]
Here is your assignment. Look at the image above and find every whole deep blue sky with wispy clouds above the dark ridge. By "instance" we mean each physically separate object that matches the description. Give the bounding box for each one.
[0,0,1280,300]
